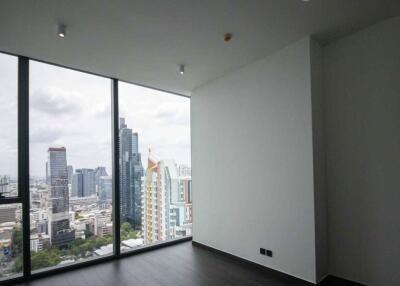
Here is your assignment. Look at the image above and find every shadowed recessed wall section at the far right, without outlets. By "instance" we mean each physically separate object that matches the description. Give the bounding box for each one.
[324,17,400,286]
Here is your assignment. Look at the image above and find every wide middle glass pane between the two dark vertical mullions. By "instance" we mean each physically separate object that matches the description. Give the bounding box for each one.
[29,61,113,271]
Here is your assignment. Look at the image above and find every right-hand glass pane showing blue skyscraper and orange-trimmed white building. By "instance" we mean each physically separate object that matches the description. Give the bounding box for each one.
[119,83,192,251]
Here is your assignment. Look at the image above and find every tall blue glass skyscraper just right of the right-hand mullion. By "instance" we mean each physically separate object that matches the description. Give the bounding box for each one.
[119,118,143,228]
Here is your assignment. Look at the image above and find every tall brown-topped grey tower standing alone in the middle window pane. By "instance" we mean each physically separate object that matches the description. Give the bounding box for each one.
[46,147,75,247]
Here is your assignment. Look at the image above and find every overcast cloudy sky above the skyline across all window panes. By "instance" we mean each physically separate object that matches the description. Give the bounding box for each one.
[0,54,190,176]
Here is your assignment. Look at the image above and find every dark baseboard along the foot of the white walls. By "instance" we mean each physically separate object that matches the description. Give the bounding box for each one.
[192,240,365,286]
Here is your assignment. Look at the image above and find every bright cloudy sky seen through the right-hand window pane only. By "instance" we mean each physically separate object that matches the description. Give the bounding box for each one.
[119,83,191,169]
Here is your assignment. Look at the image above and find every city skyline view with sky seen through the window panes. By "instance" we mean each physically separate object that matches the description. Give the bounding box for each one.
[0,54,192,279]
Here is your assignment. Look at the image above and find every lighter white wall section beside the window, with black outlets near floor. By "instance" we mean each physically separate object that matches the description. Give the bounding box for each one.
[191,38,316,282]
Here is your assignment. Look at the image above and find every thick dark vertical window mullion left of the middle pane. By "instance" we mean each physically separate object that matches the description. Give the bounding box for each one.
[18,57,31,278]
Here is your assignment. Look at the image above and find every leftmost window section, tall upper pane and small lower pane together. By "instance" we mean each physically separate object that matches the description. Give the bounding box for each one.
[0,54,23,280]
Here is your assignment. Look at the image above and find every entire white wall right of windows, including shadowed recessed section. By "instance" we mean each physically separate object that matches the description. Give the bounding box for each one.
[192,17,400,286]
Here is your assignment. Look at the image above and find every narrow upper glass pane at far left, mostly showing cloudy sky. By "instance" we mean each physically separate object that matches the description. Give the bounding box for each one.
[0,54,18,198]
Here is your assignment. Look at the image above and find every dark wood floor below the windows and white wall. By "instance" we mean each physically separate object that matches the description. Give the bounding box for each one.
[14,242,360,286]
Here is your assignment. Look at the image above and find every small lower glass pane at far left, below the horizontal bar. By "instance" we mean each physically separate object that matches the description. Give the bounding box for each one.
[0,204,22,280]
